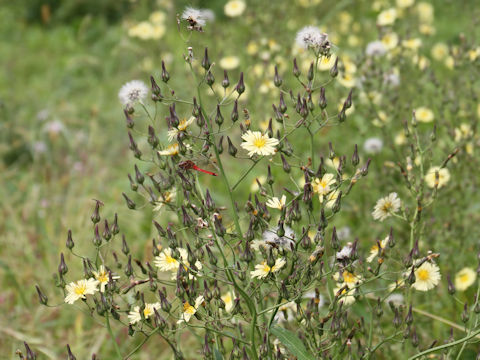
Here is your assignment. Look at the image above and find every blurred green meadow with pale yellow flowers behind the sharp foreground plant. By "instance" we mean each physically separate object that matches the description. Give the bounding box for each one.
[0,0,480,359]
